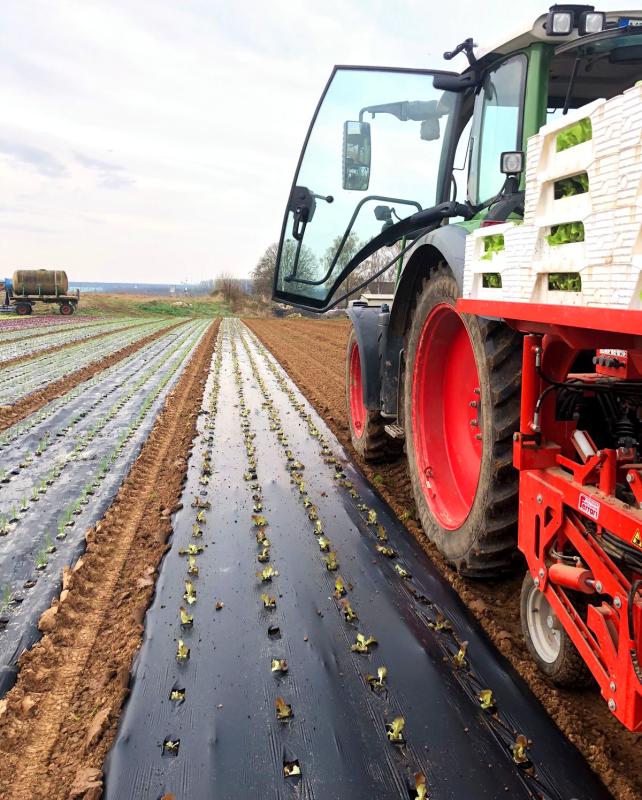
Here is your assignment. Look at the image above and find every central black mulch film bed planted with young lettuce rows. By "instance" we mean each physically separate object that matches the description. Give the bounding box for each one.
[105,320,610,800]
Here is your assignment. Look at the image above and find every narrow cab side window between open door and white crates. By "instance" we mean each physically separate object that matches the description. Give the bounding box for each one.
[470,55,527,203]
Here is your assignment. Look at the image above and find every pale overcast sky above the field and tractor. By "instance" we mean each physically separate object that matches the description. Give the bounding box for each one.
[0,0,625,282]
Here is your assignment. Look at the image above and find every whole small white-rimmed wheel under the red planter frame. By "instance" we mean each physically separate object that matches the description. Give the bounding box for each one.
[520,572,592,688]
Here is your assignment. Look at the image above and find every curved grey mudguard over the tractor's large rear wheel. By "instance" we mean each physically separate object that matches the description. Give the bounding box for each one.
[390,224,468,336]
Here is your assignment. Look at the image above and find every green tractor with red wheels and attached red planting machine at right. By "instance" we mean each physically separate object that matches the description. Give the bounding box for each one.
[273,5,642,730]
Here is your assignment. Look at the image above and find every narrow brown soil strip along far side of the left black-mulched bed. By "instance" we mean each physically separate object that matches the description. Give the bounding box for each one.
[0,323,180,431]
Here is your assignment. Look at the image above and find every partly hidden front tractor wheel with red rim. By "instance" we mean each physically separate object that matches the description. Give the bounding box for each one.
[346,329,402,461]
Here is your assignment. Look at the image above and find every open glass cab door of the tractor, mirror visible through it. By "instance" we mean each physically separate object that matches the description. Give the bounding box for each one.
[274,67,457,309]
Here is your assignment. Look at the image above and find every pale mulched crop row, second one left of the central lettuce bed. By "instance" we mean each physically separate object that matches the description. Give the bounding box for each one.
[0,321,171,403]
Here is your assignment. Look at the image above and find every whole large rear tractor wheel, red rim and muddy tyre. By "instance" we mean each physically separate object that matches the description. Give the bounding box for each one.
[404,265,522,577]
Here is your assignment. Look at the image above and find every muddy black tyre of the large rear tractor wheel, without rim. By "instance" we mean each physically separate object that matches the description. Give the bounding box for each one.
[404,265,522,578]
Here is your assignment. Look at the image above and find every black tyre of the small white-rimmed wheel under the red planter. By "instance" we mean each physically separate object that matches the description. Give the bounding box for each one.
[520,572,593,689]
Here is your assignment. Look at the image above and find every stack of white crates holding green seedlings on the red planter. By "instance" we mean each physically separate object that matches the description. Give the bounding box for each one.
[463,81,642,309]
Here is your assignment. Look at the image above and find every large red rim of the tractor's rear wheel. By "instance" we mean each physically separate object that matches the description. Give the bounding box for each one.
[412,303,482,530]
